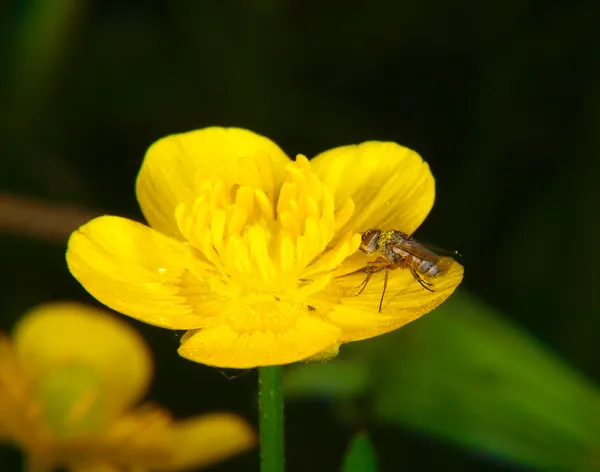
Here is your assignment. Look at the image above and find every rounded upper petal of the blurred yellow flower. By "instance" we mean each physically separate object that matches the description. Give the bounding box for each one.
[14,302,152,422]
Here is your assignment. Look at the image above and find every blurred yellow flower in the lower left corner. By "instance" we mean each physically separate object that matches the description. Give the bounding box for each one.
[0,303,255,472]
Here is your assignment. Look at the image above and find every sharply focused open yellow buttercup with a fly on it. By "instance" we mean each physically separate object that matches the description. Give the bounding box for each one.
[67,128,462,368]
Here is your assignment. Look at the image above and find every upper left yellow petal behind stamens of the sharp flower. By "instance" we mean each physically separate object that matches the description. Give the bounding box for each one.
[136,127,289,239]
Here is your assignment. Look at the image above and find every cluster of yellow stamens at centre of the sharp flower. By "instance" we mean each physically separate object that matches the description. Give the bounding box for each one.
[176,154,359,301]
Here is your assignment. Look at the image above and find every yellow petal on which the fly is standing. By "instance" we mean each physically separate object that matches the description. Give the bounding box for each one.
[327,257,463,342]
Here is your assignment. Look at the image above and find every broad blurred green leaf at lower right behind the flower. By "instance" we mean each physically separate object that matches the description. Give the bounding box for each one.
[286,293,600,471]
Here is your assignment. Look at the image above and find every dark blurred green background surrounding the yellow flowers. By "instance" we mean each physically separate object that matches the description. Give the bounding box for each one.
[0,0,600,472]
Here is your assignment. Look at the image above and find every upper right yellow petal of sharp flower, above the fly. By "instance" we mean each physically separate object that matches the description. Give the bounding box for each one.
[311,141,435,234]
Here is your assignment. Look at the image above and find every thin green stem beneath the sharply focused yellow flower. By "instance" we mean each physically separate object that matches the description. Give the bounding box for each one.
[258,366,284,472]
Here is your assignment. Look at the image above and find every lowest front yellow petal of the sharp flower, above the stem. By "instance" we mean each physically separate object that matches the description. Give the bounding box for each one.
[178,311,340,369]
